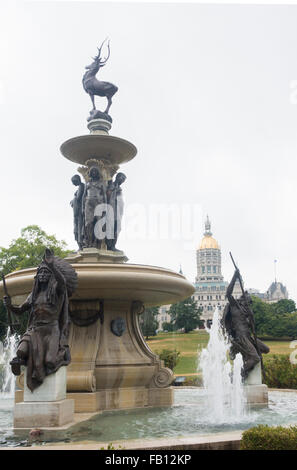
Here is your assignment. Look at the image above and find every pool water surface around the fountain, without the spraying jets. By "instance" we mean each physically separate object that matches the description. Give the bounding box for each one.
[0,387,297,447]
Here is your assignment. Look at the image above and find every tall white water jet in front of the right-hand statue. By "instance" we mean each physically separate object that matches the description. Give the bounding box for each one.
[199,309,246,423]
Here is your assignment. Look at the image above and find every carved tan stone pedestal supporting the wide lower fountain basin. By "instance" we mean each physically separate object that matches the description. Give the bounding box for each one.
[67,300,173,412]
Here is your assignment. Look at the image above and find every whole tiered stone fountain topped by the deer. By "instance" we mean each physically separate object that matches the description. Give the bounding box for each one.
[0,44,194,428]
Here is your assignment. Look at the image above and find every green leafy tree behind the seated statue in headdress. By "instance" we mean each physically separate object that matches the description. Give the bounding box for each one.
[0,225,70,340]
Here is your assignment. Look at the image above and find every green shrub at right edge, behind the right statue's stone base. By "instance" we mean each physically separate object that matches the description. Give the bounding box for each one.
[263,354,297,389]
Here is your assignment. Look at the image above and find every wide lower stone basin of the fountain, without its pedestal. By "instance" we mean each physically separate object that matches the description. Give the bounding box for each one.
[0,263,195,307]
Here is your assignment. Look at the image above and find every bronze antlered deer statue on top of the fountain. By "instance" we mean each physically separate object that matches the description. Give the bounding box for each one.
[82,39,118,115]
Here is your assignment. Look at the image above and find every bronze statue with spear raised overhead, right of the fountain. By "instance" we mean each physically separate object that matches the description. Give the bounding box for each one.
[222,253,269,378]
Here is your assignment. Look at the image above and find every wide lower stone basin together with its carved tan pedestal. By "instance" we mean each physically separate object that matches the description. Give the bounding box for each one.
[0,262,194,414]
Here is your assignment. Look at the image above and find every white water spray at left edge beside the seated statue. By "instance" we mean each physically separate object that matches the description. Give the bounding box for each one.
[0,328,19,398]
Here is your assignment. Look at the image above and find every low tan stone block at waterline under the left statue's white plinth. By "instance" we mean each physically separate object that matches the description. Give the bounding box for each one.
[14,399,74,428]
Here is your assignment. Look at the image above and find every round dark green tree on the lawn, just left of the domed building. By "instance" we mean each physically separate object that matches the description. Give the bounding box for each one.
[169,297,202,333]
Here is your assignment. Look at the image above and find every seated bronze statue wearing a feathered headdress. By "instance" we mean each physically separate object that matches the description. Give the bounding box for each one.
[3,249,77,391]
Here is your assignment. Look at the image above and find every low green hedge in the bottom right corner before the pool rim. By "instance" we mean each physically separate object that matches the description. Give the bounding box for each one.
[240,424,297,450]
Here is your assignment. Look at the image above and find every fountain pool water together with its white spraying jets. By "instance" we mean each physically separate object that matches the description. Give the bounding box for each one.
[0,311,297,447]
